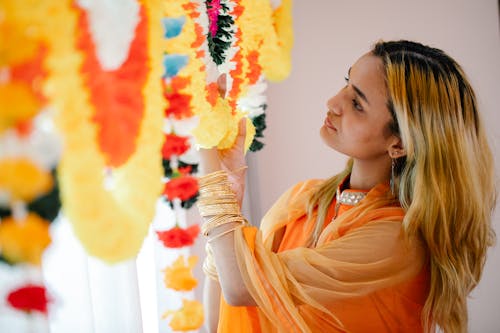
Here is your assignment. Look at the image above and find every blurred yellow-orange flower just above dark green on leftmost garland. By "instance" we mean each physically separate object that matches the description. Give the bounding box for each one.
[0,158,54,202]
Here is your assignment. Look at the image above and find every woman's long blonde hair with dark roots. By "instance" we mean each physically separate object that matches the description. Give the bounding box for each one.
[308,41,496,332]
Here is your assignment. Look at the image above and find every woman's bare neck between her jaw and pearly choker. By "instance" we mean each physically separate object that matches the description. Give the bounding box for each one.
[349,157,391,190]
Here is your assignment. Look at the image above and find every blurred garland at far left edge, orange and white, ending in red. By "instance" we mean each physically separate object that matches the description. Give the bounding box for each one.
[0,0,61,315]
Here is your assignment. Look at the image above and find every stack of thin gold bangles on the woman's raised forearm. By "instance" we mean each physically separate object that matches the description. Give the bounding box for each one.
[197,170,248,280]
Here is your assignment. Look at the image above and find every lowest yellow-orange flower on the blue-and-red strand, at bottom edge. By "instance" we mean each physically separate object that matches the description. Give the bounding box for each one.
[162,299,205,331]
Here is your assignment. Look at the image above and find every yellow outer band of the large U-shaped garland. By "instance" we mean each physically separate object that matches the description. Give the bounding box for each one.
[45,0,163,262]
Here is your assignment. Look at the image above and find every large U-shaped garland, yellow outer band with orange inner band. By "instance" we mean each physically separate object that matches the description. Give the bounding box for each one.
[44,0,163,262]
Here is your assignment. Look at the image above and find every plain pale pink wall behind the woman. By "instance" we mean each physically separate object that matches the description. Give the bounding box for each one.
[249,0,500,332]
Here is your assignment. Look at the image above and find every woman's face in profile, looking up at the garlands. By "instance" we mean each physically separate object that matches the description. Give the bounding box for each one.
[320,53,394,160]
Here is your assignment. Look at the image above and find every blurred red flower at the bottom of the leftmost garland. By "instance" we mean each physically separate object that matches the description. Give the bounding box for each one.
[7,284,49,314]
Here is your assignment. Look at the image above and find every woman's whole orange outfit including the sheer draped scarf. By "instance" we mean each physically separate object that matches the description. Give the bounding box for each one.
[218,181,429,332]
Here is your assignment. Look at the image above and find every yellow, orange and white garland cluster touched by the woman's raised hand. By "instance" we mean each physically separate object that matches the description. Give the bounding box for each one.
[193,0,293,151]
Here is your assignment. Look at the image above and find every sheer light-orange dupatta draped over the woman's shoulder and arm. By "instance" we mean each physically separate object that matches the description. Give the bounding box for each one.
[221,181,425,332]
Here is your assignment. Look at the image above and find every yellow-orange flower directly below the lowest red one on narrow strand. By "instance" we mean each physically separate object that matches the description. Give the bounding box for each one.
[164,255,198,291]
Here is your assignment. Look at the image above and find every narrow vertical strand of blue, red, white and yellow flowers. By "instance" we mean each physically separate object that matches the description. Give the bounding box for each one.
[156,0,204,331]
